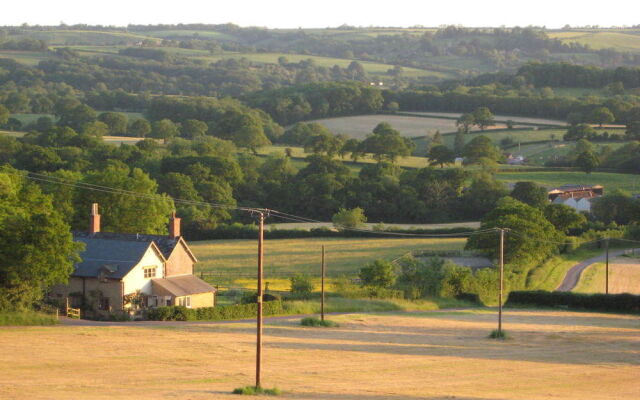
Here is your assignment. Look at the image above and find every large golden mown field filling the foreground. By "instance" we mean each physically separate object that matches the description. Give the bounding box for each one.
[0,310,640,400]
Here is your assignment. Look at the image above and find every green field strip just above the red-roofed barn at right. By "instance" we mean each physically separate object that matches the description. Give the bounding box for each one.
[496,171,640,193]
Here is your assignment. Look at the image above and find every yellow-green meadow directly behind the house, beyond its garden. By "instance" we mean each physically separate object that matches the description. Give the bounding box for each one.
[190,238,465,284]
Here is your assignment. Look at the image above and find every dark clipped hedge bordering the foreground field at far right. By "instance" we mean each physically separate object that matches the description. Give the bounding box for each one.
[506,291,640,313]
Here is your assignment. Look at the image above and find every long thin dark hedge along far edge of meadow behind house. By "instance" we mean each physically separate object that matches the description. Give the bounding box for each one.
[185,224,475,240]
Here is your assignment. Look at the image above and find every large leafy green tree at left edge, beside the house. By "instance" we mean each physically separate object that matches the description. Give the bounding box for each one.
[0,168,81,310]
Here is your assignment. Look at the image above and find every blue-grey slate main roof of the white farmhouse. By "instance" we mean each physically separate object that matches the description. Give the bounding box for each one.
[72,237,162,279]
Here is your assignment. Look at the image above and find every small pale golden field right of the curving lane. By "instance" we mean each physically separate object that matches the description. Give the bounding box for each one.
[573,257,640,294]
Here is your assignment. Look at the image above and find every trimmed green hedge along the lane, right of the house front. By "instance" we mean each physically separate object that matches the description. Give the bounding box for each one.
[147,301,285,321]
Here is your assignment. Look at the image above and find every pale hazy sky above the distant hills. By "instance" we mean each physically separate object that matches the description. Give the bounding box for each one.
[0,0,640,28]
